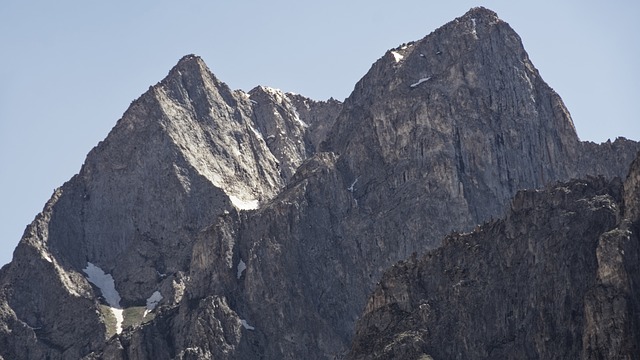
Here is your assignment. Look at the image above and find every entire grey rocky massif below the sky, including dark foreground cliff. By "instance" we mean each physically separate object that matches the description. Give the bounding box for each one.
[0,8,640,360]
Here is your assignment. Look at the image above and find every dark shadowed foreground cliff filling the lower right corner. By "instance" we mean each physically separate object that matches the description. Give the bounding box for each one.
[350,153,640,359]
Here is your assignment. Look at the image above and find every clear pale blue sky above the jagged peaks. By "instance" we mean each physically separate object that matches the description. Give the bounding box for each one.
[0,0,640,264]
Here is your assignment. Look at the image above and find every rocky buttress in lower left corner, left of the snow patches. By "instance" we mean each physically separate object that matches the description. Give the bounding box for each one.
[0,191,106,359]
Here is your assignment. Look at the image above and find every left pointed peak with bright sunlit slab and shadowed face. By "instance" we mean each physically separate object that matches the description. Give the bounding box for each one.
[47,56,284,305]
